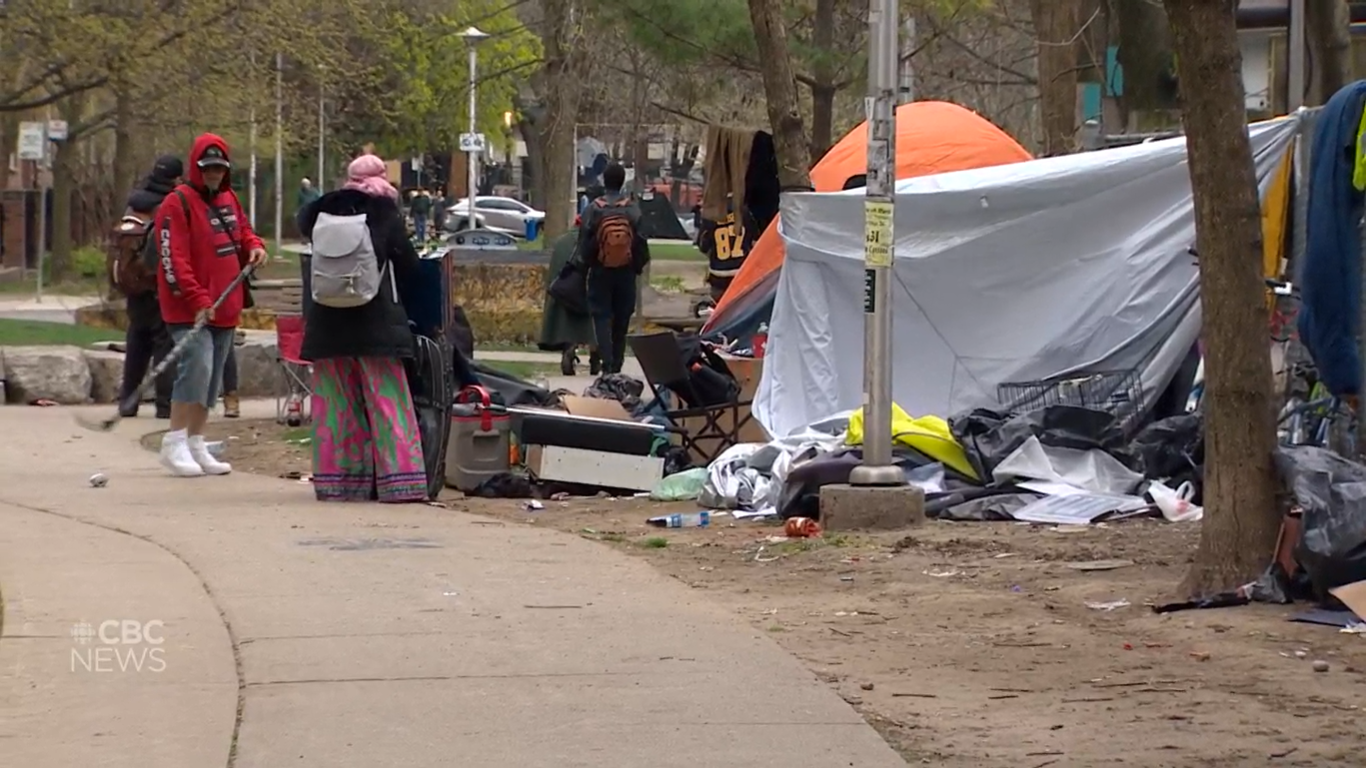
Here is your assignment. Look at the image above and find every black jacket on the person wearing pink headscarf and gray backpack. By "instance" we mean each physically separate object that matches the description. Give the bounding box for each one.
[299,190,418,361]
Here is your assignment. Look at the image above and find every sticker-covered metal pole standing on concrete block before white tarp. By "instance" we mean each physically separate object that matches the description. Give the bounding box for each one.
[850,0,906,485]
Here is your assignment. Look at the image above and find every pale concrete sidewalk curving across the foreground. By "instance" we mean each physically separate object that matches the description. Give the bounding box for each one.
[0,407,904,768]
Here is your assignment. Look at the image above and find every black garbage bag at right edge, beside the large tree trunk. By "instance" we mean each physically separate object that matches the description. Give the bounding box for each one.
[1276,445,1366,604]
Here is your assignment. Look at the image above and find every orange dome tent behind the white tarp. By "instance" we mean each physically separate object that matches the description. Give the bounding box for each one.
[702,101,1033,338]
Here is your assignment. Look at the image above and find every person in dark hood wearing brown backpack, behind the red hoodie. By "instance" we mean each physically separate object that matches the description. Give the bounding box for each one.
[108,154,184,418]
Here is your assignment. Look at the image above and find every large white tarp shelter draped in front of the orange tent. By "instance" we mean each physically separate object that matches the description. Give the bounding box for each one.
[754,118,1298,436]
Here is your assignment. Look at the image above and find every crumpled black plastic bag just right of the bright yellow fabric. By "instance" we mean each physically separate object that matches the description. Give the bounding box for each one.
[948,406,1134,480]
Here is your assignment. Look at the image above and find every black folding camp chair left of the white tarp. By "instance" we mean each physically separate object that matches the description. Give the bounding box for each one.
[627,331,753,463]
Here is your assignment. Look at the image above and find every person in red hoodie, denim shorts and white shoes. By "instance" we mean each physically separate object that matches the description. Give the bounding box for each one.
[156,134,266,477]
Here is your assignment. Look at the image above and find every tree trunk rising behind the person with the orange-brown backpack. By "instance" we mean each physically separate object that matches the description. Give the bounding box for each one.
[541,0,582,243]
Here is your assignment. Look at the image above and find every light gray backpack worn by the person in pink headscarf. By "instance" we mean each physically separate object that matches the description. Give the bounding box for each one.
[311,213,398,309]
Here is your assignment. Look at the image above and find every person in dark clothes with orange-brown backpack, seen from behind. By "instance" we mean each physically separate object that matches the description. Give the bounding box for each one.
[579,163,650,373]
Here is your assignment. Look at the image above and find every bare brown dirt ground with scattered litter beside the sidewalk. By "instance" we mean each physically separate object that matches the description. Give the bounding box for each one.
[202,421,1366,768]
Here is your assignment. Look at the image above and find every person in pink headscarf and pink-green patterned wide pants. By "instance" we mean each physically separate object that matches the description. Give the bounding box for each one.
[299,154,428,502]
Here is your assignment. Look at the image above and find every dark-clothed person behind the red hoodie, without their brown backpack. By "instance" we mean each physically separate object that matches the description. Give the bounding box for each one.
[111,154,184,418]
